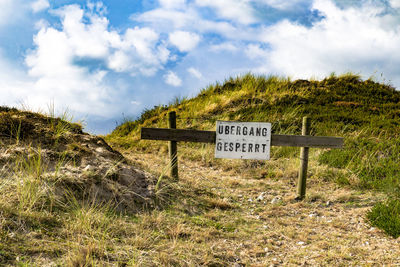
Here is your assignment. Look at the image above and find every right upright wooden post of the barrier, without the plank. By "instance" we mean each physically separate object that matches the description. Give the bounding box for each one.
[296,117,310,200]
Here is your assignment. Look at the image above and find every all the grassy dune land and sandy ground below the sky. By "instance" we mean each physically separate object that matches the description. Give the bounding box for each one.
[0,74,400,266]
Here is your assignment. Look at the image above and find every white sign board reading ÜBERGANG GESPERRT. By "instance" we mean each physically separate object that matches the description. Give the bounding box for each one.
[215,121,271,160]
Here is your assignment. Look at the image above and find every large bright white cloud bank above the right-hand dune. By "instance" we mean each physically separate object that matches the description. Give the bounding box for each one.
[247,0,400,86]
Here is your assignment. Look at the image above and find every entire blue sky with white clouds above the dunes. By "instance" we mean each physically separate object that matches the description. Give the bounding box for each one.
[0,0,400,134]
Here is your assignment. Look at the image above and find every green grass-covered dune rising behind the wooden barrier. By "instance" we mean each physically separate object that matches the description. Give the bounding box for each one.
[107,73,400,239]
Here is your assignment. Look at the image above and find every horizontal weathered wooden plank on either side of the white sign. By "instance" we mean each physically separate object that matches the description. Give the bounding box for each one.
[141,128,343,148]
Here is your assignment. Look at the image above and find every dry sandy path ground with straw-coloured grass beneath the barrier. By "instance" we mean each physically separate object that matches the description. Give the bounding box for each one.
[125,153,400,267]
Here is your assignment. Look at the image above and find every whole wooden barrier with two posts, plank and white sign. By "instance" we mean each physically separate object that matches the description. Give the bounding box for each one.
[141,111,344,199]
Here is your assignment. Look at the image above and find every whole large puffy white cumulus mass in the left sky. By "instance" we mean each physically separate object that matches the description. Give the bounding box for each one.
[25,5,173,116]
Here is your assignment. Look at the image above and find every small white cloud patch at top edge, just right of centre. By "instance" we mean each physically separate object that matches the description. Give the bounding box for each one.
[196,0,257,24]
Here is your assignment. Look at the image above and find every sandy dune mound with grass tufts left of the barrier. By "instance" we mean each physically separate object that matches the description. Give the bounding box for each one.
[0,107,155,266]
